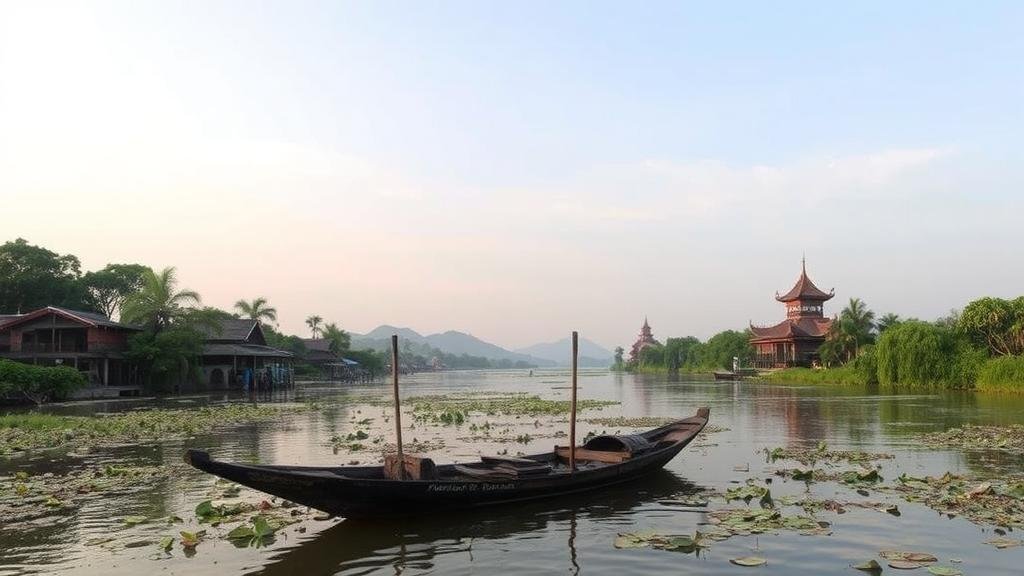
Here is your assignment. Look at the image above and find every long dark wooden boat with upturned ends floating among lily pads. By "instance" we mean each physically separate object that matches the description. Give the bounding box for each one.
[185,408,710,519]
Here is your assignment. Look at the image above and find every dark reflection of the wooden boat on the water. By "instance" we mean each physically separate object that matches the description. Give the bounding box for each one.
[250,470,699,576]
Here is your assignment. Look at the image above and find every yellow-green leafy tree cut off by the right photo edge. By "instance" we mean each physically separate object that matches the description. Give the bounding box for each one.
[956,296,1024,356]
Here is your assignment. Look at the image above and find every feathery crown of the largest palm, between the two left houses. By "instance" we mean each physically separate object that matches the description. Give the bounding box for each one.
[121,266,200,332]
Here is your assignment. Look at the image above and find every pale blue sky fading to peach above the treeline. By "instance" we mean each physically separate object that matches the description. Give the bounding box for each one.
[0,0,1024,347]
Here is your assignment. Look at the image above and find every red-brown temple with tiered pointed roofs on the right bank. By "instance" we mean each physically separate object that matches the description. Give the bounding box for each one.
[751,261,836,368]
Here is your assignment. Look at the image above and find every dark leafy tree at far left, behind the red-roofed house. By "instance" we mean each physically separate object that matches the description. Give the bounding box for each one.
[0,238,93,313]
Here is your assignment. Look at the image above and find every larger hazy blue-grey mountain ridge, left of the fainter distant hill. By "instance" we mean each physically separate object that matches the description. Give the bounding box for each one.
[351,325,556,366]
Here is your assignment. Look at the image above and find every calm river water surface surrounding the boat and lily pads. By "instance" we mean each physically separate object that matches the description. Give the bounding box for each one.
[0,371,1024,576]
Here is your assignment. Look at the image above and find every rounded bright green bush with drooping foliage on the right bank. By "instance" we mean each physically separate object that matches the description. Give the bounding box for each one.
[874,321,986,388]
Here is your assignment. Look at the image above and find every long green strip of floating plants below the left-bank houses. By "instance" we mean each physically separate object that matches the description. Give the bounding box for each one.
[0,404,307,455]
